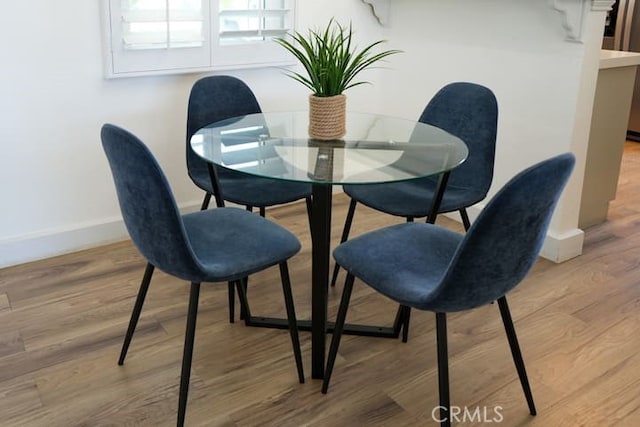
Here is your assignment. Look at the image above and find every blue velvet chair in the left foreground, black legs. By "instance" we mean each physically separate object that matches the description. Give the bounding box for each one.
[101,124,304,426]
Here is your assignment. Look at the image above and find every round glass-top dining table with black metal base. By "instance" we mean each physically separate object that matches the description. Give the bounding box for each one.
[190,111,468,378]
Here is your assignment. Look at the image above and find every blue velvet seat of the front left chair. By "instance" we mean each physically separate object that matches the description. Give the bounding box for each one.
[183,208,300,282]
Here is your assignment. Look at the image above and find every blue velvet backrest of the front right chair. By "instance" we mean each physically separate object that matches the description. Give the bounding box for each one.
[427,153,575,312]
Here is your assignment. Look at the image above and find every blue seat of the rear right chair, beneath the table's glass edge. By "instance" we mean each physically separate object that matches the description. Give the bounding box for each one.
[343,179,485,218]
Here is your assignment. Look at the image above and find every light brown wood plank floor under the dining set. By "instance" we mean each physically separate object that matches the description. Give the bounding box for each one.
[0,143,640,427]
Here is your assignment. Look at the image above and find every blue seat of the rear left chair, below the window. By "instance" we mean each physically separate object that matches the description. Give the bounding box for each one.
[190,168,311,207]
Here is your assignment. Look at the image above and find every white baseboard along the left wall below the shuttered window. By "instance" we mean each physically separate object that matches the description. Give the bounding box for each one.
[0,203,200,268]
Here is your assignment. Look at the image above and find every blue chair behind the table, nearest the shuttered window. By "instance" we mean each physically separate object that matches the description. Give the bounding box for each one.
[186,76,311,322]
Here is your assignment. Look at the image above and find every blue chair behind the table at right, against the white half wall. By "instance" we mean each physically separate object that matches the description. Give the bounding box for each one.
[331,82,498,342]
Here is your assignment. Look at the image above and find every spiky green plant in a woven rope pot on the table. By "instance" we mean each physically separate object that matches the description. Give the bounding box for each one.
[275,19,401,140]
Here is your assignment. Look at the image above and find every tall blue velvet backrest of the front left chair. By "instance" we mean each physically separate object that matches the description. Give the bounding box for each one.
[101,124,201,280]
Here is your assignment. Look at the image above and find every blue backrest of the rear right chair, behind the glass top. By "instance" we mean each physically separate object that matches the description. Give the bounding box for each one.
[419,82,498,204]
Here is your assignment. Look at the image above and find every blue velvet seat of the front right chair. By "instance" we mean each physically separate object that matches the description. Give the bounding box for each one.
[333,223,463,309]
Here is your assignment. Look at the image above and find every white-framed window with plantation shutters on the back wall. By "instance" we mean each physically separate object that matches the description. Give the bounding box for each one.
[103,0,295,77]
